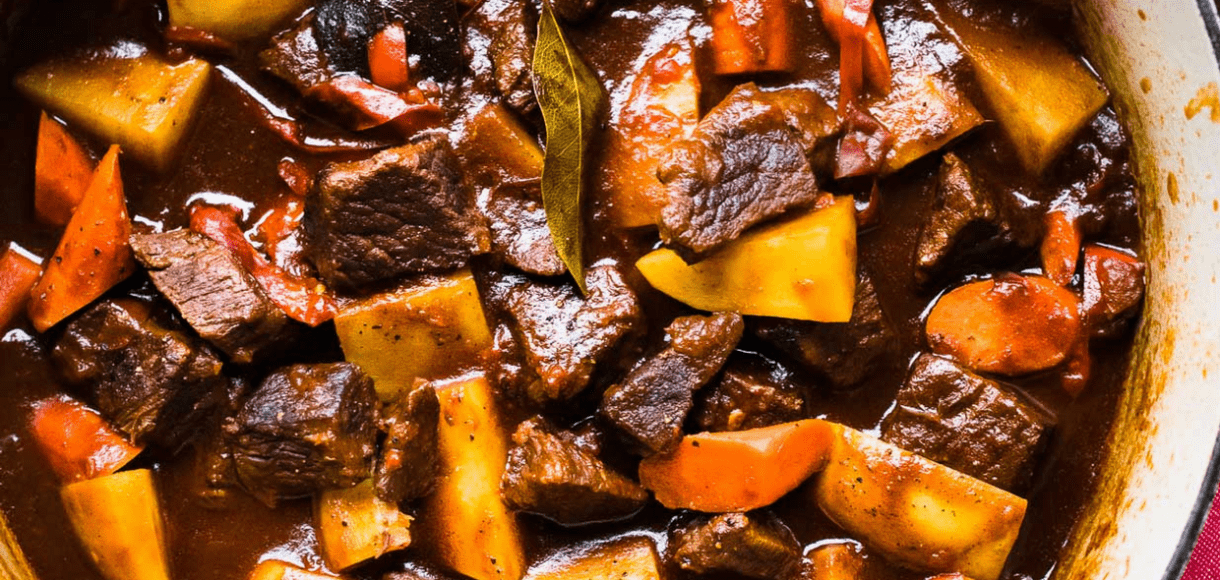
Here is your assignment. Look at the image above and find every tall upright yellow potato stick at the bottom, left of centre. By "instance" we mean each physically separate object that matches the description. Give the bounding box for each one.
[417,376,525,580]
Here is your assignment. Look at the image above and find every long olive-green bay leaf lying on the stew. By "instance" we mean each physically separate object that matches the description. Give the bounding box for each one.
[533,1,609,292]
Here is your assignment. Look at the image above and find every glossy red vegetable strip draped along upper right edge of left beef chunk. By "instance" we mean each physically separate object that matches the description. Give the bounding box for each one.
[190,206,337,326]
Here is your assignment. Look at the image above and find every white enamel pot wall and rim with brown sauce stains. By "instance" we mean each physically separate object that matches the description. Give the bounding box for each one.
[1073,0,1220,580]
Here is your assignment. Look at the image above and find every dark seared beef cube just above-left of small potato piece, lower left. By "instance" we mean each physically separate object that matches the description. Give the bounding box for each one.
[226,363,377,506]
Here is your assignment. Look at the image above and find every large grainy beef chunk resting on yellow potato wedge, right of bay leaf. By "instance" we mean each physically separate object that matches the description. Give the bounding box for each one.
[658,83,837,256]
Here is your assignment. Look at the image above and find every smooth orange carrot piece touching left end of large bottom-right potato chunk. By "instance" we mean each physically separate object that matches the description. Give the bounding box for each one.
[639,419,837,513]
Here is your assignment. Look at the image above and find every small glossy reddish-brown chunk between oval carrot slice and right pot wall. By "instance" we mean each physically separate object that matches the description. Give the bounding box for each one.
[1081,244,1144,336]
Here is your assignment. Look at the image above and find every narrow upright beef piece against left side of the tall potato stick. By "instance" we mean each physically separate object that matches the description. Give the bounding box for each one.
[373,381,440,504]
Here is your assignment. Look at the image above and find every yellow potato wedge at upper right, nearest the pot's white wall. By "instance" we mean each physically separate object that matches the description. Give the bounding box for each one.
[937,2,1110,173]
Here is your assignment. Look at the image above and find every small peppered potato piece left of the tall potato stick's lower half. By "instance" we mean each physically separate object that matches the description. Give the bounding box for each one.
[314,480,411,570]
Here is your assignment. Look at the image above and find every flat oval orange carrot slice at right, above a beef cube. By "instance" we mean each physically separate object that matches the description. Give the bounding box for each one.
[926,274,1083,375]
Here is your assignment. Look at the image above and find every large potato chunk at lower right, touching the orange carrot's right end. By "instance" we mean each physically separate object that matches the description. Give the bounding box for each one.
[814,427,1026,580]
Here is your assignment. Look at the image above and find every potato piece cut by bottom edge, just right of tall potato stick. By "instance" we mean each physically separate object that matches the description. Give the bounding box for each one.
[526,537,661,580]
